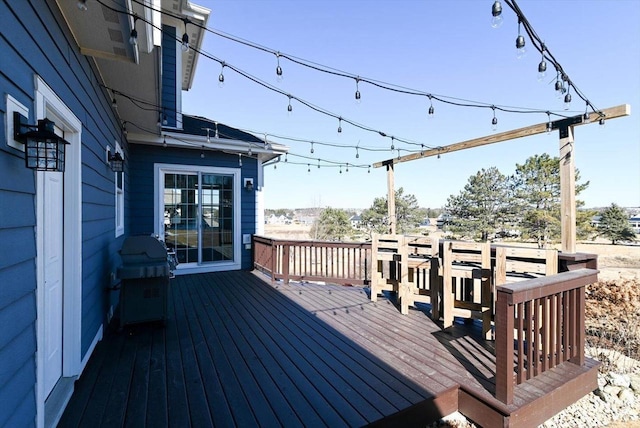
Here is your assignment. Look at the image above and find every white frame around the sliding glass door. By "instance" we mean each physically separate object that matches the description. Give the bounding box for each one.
[153,163,242,275]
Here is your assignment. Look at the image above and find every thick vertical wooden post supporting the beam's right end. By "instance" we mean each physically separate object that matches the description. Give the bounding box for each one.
[560,125,576,254]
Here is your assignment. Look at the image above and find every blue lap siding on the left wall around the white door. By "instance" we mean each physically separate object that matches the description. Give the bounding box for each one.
[0,0,126,426]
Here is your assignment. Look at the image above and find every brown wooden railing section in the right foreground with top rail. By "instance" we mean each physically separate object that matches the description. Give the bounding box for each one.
[495,268,598,404]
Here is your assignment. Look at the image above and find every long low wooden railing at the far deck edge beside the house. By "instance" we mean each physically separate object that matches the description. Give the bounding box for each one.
[253,236,371,285]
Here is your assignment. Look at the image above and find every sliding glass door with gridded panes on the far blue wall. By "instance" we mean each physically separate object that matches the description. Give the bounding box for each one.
[159,167,239,269]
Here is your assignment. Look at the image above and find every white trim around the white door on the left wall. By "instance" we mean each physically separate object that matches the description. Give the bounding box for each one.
[35,76,82,427]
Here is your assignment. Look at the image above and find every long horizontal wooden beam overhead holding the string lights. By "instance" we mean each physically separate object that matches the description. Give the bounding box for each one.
[373,104,631,168]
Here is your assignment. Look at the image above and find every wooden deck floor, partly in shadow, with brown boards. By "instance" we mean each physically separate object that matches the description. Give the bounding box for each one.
[59,271,597,427]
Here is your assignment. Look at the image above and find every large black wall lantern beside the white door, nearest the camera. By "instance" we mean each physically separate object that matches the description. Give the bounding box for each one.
[13,112,69,172]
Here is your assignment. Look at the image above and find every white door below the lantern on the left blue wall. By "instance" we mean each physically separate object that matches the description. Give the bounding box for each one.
[38,172,64,396]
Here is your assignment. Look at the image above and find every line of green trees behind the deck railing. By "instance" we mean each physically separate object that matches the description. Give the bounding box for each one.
[311,153,635,247]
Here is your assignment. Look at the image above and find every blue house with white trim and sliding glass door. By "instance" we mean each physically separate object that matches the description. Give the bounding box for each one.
[0,0,284,427]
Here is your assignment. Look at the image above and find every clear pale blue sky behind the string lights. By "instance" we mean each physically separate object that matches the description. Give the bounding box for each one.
[183,0,640,209]
